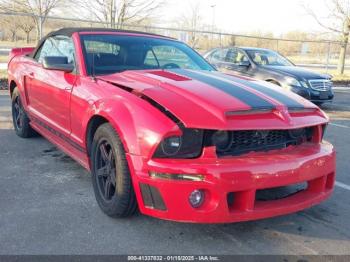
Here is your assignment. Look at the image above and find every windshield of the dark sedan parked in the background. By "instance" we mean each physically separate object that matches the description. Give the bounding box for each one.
[247,50,293,66]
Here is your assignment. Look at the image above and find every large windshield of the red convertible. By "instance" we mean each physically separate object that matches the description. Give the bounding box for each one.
[81,34,215,75]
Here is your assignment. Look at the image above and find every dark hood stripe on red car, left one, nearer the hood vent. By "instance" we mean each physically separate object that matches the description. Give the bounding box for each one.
[174,70,276,109]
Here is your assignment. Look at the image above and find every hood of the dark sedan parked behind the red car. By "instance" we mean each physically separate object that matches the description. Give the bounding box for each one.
[263,66,330,80]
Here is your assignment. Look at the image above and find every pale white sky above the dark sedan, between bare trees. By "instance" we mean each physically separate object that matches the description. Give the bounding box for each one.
[164,0,334,36]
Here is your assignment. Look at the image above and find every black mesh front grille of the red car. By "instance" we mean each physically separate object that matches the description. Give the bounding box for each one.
[212,127,313,157]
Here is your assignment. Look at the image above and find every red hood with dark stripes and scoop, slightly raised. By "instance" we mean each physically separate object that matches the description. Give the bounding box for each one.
[97,69,327,130]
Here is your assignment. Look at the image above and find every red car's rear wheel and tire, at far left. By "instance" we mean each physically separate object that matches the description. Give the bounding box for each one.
[11,87,35,138]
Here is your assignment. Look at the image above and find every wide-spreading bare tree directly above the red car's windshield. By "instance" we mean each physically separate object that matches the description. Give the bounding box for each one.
[77,0,164,29]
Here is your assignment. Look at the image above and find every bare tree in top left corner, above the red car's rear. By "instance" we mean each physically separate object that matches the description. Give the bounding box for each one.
[0,0,64,41]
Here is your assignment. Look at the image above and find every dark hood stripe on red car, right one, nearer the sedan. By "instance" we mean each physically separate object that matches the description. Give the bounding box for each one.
[217,71,305,108]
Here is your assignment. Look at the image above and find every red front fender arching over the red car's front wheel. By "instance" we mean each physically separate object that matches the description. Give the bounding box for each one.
[83,96,178,160]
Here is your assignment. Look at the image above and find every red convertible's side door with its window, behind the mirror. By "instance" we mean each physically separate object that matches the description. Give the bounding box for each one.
[26,36,76,135]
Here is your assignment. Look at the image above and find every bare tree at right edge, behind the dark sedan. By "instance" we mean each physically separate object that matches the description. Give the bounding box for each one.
[305,0,350,75]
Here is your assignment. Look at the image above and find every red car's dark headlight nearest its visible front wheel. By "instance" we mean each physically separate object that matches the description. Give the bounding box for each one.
[153,128,203,158]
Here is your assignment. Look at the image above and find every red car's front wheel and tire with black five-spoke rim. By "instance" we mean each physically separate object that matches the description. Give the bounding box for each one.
[90,123,137,218]
